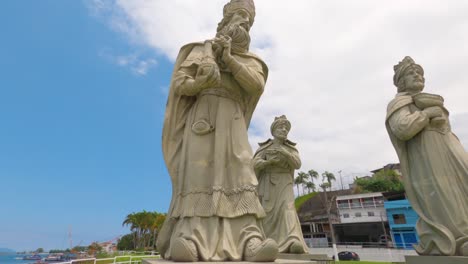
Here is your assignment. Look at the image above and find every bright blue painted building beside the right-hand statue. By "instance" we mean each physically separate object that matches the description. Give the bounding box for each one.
[384,199,419,249]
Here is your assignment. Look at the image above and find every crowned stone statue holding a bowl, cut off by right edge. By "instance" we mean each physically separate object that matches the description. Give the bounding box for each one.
[386,57,468,256]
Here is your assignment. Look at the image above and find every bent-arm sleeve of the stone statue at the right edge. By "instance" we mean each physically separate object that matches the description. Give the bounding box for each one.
[388,106,430,141]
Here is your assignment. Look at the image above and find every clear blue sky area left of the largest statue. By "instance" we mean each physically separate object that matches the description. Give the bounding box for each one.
[0,0,172,250]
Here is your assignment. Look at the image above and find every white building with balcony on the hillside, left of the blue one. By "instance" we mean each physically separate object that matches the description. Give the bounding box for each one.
[336,192,387,224]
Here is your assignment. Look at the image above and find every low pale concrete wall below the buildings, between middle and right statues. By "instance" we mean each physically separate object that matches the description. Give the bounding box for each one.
[309,246,418,262]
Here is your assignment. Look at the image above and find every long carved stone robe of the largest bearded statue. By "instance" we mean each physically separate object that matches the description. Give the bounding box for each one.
[157,43,268,261]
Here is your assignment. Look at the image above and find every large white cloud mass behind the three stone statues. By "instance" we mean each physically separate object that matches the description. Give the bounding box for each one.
[87,0,468,190]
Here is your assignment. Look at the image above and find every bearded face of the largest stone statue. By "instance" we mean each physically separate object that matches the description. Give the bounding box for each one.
[217,9,250,52]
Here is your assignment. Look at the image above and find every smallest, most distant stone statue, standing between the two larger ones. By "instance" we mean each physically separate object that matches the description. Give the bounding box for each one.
[253,115,309,254]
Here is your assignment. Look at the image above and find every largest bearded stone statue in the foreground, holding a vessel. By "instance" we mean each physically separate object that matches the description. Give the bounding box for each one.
[157,0,278,261]
